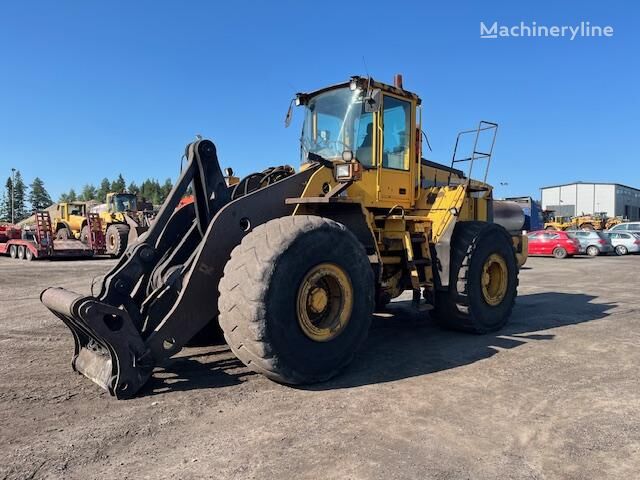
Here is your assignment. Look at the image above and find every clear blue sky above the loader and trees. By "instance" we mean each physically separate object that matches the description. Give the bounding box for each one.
[0,0,640,197]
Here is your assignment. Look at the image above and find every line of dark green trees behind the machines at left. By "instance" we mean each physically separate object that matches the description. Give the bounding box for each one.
[0,170,173,223]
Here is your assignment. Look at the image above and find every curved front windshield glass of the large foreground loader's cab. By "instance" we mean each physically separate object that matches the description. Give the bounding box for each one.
[300,87,373,166]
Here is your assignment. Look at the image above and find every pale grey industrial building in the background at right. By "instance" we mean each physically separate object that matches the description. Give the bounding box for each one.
[540,182,640,221]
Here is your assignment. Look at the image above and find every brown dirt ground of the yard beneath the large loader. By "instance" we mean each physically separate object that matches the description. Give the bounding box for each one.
[0,253,640,479]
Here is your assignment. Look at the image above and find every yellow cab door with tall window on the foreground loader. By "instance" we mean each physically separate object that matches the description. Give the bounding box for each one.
[376,93,416,207]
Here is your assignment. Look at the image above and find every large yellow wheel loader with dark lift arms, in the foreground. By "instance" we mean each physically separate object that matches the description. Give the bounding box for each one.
[41,77,527,399]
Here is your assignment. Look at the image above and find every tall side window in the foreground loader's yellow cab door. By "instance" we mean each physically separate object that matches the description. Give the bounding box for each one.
[382,95,411,170]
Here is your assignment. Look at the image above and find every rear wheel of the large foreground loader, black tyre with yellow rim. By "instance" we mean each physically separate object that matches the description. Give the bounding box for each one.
[431,222,518,334]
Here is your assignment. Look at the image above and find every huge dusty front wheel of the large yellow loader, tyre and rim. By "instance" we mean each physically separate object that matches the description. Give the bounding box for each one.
[219,216,375,384]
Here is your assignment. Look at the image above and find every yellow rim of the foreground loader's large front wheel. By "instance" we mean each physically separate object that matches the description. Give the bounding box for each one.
[296,263,353,342]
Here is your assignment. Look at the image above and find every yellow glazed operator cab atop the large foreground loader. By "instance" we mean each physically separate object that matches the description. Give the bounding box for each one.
[296,76,420,207]
